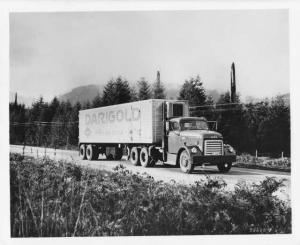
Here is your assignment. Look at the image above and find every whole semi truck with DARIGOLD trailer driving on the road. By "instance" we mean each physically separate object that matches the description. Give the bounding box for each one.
[79,99,236,173]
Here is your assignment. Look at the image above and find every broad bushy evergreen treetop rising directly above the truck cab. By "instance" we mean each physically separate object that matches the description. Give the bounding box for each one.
[178,76,206,106]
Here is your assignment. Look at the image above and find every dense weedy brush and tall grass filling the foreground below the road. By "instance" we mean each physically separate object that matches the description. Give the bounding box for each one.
[10,154,291,237]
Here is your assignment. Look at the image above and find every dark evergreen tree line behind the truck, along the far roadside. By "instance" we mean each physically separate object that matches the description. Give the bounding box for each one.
[9,76,290,157]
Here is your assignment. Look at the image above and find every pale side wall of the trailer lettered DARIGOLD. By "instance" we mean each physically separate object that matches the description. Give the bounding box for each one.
[79,99,164,144]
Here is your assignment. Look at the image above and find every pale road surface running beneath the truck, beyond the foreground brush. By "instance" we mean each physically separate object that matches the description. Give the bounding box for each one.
[10,145,291,201]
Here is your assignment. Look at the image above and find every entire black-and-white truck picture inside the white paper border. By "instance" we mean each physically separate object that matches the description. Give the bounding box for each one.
[0,0,299,242]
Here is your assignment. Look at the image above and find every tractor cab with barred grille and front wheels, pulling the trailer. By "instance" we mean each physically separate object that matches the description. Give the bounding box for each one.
[165,100,236,173]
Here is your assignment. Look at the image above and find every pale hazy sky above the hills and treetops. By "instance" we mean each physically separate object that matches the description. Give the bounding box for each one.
[10,9,289,100]
